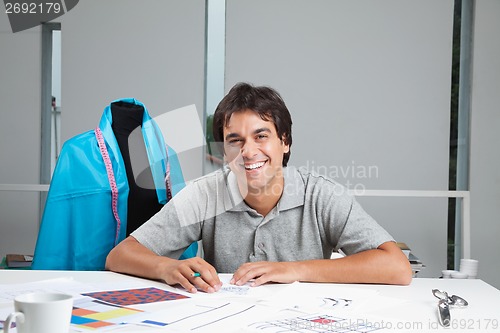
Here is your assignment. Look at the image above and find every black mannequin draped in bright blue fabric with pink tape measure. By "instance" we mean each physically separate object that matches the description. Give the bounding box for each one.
[31,98,198,271]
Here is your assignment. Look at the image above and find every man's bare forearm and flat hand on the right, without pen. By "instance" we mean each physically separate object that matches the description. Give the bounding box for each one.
[231,242,412,286]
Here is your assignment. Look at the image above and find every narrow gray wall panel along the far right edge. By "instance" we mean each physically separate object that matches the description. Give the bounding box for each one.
[470,0,500,288]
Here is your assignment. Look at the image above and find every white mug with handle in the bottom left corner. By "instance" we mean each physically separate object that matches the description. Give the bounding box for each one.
[3,292,73,333]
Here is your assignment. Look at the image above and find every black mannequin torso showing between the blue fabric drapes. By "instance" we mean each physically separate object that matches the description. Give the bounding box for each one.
[111,101,162,236]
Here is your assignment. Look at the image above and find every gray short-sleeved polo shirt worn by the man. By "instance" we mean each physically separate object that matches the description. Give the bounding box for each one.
[132,167,393,273]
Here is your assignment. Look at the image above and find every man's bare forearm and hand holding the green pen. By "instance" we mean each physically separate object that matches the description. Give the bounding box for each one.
[106,236,222,293]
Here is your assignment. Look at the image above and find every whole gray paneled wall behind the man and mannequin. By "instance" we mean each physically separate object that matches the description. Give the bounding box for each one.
[0,0,500,287]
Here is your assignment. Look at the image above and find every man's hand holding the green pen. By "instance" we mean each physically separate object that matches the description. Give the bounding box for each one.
[162,257,222,293]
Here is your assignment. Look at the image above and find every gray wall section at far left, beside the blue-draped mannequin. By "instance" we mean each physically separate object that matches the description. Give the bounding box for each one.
[0,18,41,256]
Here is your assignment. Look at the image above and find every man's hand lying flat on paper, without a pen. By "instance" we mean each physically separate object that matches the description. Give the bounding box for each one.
[230,261,299,287]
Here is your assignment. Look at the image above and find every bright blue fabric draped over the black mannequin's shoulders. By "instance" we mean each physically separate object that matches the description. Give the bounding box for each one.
[32,99,198,270]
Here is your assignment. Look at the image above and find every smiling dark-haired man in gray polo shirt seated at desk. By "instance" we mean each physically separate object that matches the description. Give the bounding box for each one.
[106,83,411,292]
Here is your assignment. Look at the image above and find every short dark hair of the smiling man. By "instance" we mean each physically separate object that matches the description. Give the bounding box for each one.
[213,82,292,167]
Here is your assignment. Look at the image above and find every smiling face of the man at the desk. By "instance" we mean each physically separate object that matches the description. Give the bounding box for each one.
[223,110,290,197]
